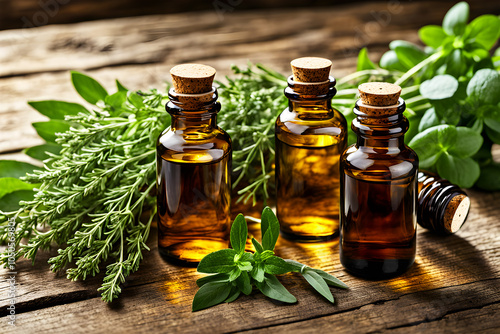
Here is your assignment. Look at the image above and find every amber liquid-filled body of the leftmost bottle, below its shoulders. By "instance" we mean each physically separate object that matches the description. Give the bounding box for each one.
[157,132,231,265]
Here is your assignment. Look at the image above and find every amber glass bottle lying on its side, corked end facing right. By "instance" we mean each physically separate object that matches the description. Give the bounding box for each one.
[417,171,470,234]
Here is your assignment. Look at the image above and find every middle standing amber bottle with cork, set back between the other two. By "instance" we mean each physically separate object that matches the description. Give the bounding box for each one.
[275,57,347,242]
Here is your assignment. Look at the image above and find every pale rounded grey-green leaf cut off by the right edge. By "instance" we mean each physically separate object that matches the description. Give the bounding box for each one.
[467,69,500,105]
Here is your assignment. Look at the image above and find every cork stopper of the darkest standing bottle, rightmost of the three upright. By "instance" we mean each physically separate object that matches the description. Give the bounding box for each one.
[358,82,401,107]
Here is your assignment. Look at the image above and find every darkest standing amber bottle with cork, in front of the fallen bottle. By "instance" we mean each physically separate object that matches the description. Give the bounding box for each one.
[340,82,418,279]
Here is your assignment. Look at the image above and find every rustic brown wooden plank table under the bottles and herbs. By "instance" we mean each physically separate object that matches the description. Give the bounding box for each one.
[0,1,500,333]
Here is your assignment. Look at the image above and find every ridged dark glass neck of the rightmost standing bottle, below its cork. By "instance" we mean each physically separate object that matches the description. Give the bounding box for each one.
[351,99,409,150]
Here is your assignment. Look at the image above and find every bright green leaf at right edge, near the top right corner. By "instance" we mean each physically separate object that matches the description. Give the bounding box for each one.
[466,15,500,50]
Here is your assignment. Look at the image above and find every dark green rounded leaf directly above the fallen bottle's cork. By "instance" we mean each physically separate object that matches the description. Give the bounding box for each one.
[437,154,480,188]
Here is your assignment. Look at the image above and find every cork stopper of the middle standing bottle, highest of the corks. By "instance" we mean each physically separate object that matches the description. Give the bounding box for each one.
[290,57,332,82]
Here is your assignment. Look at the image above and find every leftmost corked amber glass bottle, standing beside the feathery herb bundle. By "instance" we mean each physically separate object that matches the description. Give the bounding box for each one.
[157,64,231,265]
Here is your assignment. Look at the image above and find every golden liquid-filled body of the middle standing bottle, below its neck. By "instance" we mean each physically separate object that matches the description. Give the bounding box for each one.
[276,111,346,242]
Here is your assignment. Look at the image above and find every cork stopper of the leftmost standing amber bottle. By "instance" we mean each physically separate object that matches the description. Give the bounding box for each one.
[170,64,215,94]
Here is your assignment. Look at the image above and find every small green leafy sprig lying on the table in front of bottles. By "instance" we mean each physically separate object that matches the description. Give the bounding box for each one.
[192,207,347,312]
